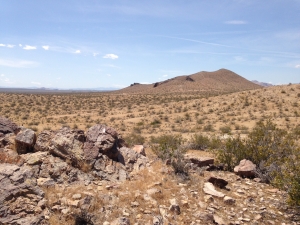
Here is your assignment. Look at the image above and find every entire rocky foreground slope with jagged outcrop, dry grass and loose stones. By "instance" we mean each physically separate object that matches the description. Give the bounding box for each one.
[0,117,298,225]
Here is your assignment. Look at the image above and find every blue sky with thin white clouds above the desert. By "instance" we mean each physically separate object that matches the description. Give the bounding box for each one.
[0,0,300,89]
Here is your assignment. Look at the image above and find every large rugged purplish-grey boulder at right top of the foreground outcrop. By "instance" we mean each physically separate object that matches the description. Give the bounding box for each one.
[83,124,123,164]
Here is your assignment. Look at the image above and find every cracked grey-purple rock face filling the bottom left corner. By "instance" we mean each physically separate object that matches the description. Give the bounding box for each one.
[0,163,45,224]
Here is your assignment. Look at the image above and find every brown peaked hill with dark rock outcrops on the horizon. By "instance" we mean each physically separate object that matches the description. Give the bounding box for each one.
[115,69,261,94]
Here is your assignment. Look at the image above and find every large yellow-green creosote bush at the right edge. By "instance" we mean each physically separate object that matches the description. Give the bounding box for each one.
[217,119,300,206]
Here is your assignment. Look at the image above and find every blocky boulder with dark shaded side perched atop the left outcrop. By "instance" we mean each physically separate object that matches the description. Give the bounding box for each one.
[15,128,36,154]
